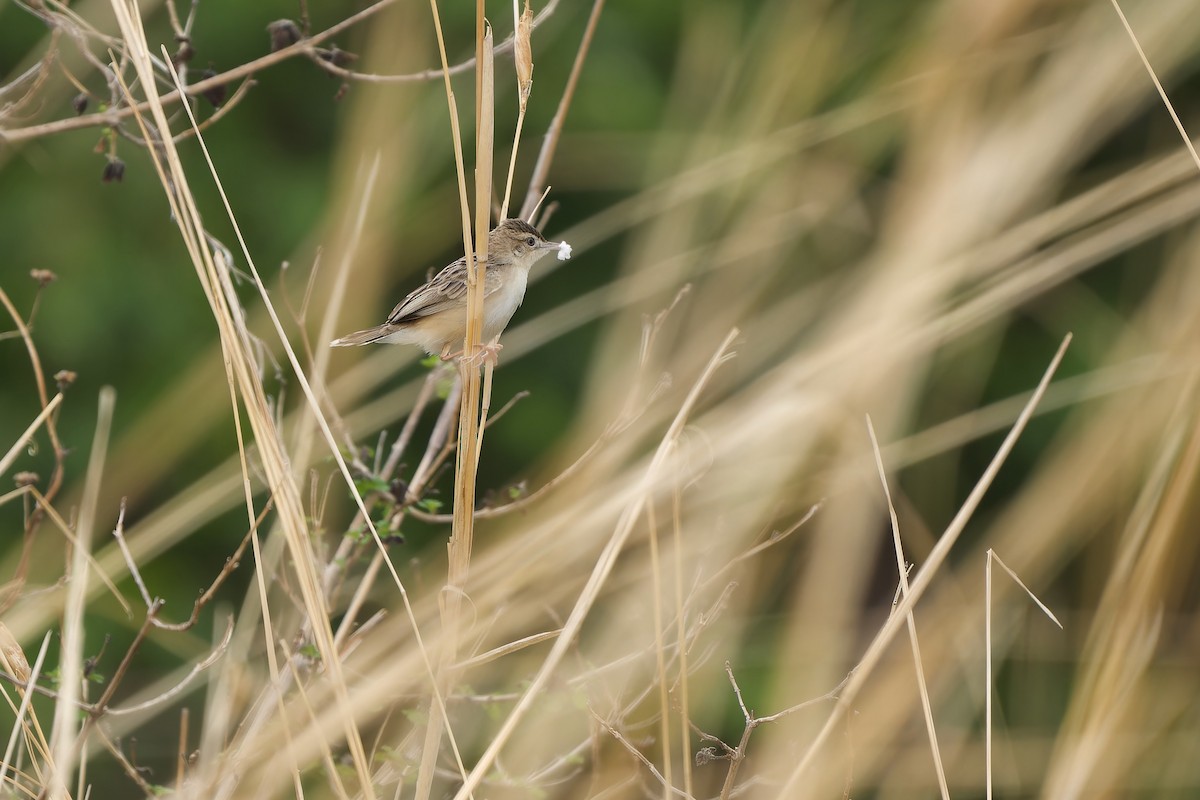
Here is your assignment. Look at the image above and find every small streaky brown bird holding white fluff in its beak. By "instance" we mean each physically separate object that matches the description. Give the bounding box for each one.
[330,219,571,359]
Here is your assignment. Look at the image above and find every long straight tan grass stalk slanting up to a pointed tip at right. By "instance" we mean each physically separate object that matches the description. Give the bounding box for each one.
[782,335,1070,796]
